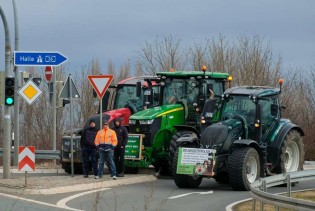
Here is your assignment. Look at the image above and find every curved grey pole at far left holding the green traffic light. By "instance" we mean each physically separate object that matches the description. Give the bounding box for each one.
[0,6,11,179]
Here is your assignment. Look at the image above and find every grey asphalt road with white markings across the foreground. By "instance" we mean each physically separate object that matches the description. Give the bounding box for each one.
[0,169,315,211]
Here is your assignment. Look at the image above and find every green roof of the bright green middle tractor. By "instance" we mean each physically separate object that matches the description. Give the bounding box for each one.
[156,71,229,79]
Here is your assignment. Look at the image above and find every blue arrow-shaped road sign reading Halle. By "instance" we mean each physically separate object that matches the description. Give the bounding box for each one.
[14,51,68,66]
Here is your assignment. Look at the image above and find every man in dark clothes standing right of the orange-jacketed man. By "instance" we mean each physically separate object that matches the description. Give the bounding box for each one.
[113,118,128,177]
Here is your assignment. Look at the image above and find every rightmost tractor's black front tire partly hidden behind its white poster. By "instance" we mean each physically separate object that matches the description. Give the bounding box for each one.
[172,145,202,188]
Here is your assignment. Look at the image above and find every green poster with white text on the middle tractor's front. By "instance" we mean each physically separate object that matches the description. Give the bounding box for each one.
[125,134,142,160]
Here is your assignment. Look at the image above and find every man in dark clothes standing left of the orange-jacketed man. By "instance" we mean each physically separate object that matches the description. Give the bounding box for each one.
[80,120,98,178]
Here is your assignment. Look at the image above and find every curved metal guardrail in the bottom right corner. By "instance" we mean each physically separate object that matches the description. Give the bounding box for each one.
[250,170,315,210]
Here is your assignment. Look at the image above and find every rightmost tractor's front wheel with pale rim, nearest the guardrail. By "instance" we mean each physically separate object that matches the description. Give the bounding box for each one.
[228,147,261,191]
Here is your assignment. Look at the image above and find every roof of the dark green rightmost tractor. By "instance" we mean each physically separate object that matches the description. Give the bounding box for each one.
[224,86,280,97]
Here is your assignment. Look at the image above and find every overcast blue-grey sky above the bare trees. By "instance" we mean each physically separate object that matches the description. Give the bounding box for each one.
[0,0,315,72]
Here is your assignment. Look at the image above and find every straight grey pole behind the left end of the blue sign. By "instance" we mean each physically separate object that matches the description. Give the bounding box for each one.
[12,0,21,166]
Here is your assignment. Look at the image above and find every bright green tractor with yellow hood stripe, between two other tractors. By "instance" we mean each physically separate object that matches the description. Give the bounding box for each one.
[125,68,229,175]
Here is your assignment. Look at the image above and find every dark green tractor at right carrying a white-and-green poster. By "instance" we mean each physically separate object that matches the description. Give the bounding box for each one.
[172,80,305,190]
